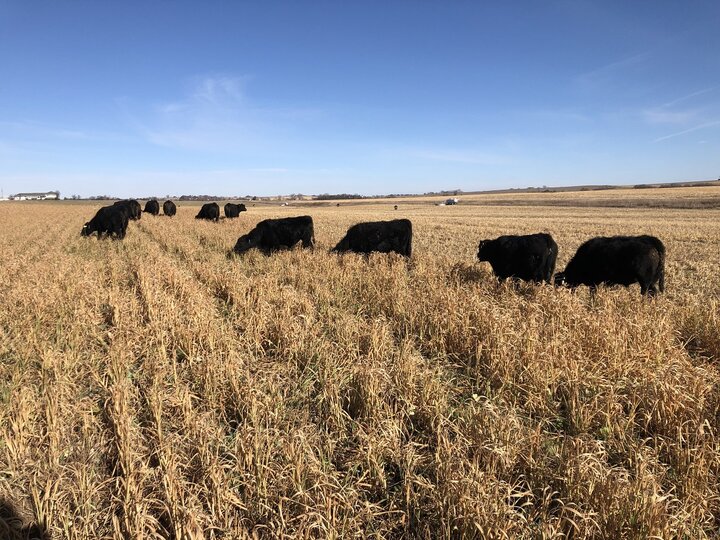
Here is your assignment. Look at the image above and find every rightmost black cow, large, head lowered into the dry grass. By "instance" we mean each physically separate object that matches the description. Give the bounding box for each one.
[555,236,665,295]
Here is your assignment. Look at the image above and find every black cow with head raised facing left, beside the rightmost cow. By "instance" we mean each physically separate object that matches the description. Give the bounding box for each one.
[477,233,557,283]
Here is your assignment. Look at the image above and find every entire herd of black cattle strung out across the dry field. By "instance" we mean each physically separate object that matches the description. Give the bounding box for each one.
[81,200,665,295]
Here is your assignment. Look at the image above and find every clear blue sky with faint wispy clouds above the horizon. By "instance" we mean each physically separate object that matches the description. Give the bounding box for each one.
[0,0,720,197]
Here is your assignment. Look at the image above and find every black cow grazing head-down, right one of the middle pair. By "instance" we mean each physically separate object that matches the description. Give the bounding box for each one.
[332,219,412,257]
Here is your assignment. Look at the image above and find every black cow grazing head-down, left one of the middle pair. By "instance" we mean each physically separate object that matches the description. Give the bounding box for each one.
[233,216,315,255]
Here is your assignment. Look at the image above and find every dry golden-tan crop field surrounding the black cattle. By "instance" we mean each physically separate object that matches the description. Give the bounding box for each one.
[0,190,720,539]
